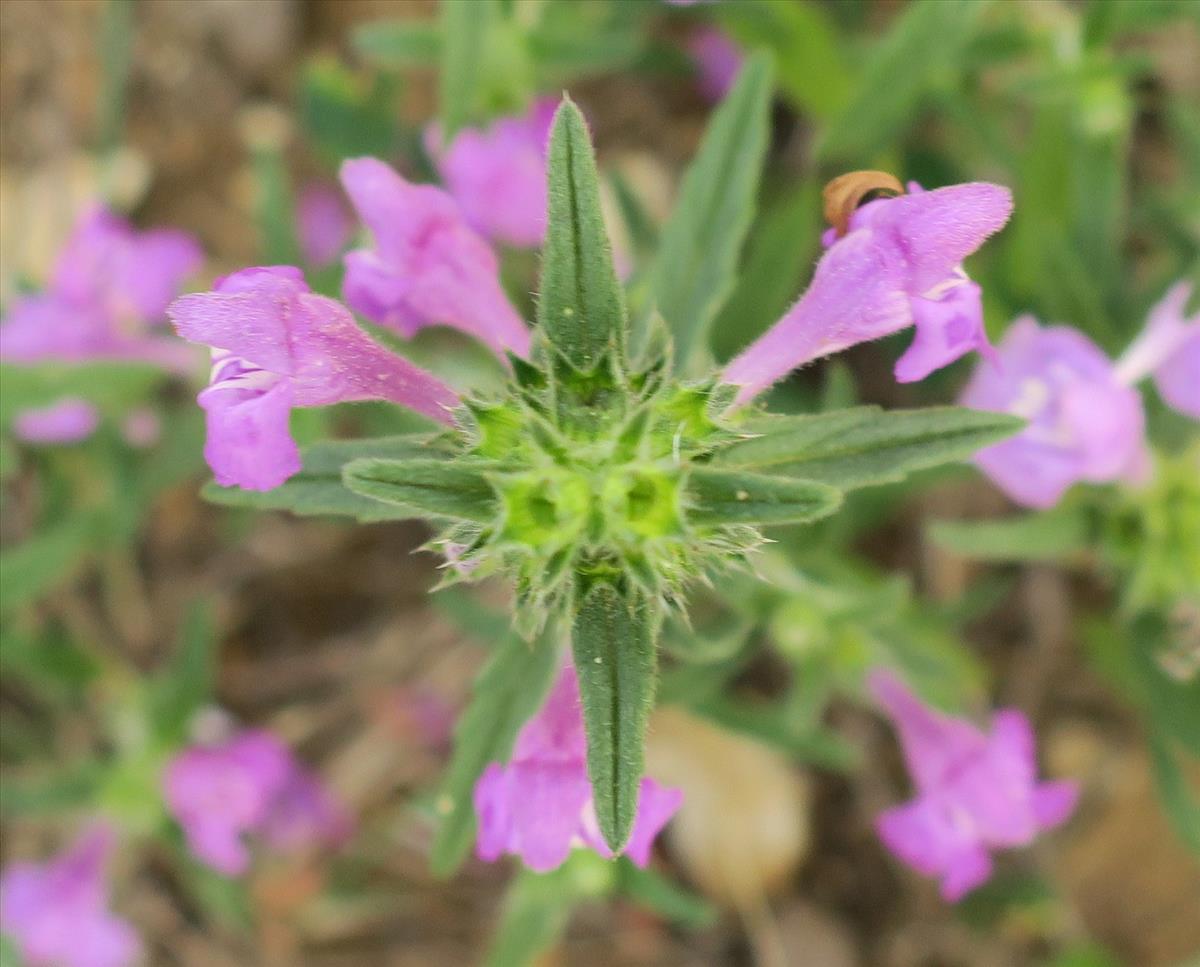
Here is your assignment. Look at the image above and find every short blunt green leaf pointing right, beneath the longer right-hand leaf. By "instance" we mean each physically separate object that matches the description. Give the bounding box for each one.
[686,468,841,527]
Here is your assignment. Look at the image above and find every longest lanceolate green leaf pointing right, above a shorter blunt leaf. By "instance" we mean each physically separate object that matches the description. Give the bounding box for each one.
[713,407,1024,491]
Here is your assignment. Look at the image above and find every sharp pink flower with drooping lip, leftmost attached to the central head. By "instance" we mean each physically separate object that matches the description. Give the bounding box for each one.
[168,265,458,491]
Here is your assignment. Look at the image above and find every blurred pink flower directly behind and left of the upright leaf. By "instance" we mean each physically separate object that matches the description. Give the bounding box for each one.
[425,97,558,248]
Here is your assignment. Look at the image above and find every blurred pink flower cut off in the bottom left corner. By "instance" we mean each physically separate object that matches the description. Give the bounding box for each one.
[0,824,140,967]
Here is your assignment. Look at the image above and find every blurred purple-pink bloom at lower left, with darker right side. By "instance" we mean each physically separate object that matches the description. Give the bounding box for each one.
[163,729,350,876]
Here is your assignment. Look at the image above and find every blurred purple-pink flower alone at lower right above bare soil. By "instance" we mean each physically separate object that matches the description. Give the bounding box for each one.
[869,672,1079,902]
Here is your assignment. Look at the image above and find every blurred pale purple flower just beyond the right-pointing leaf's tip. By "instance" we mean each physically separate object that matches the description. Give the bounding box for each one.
[960,316,1147,507]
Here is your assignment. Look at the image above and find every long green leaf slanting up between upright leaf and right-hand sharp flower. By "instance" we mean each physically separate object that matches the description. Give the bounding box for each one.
[650,53,772,368]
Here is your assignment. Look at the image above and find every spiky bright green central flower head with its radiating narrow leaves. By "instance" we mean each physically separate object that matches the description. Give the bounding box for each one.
[211,83,1021,865]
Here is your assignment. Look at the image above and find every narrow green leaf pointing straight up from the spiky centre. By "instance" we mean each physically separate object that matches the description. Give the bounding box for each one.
[538,100,625,372]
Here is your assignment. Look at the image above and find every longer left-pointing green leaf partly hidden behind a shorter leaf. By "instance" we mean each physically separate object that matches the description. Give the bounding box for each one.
[202,434,437,523]
